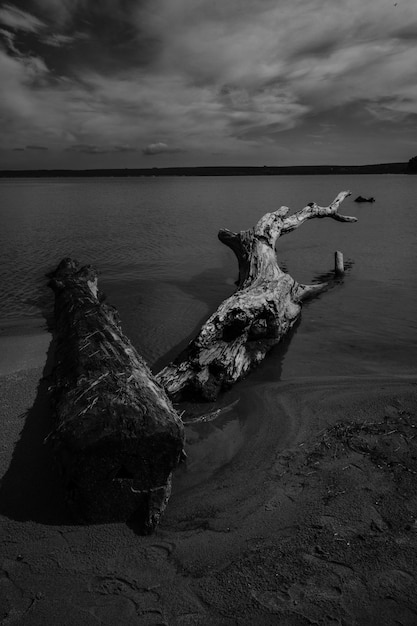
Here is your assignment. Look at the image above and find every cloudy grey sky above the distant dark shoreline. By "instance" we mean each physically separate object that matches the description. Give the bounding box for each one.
[0,0,417,169]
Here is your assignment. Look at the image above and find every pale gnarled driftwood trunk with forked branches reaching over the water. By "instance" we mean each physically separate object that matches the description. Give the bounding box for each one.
[157,191,356,401]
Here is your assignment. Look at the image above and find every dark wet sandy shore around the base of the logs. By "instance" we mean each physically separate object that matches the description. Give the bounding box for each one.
[0,333,417,626]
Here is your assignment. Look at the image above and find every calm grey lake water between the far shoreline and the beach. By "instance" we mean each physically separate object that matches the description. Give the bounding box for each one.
[0,175,417,482]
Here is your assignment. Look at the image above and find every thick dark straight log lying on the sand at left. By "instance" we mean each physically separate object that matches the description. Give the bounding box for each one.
[48,259,184,533]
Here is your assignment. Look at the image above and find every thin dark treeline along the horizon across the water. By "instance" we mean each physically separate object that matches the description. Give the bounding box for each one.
[0,163,413,178]
